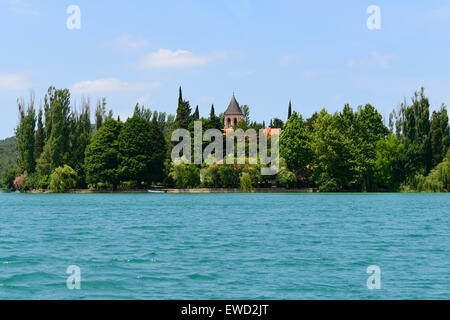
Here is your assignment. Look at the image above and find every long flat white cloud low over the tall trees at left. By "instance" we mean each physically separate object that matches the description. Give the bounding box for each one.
[70,78,160,94]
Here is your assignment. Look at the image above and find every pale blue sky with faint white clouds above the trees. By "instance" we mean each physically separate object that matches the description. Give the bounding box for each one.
[0,0,450,139]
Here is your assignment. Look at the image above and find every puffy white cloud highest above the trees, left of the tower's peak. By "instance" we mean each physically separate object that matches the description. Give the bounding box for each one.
[139,49,226,69]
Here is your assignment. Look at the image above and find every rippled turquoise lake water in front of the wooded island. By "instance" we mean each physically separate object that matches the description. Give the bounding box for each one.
[0,193,450,299]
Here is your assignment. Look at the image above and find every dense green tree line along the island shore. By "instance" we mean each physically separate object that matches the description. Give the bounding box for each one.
[3,87,450,192]
